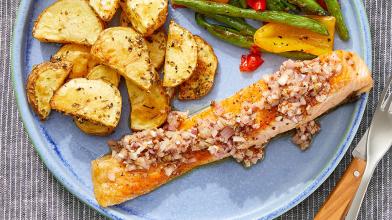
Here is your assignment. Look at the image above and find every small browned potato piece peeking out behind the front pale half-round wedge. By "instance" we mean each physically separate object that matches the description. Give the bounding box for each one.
[87,65,120,87]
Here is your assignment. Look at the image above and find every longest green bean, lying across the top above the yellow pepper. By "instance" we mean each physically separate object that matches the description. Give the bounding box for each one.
[172,0,328,35]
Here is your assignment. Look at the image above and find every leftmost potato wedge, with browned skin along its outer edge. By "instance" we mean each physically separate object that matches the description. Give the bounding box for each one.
[26,62,72,120]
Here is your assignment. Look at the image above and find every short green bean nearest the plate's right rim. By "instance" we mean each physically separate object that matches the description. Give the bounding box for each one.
[324,0,350,41]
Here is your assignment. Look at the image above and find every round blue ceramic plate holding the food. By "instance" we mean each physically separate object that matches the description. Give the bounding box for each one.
[12,0,371,219]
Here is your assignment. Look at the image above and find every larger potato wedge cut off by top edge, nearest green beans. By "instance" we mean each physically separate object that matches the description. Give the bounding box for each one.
[125,0,168,37]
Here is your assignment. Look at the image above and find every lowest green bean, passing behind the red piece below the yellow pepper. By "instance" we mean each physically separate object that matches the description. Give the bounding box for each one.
[195,13,316,60]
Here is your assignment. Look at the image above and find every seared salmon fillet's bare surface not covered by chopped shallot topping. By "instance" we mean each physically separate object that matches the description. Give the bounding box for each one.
[91,51,373,207]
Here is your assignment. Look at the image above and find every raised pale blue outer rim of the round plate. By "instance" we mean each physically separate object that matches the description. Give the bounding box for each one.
[10,0,372,219]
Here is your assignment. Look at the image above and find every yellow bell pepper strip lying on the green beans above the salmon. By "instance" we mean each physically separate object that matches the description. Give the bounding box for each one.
[254,16,336,56]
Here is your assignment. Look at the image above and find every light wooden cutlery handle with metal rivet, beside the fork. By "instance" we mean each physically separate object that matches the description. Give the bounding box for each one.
[314,158,366,220]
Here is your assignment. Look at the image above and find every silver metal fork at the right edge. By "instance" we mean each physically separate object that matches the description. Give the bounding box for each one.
[346,76,392,220]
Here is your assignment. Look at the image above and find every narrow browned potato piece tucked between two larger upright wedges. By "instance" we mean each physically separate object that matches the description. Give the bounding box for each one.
[146,29,167,69]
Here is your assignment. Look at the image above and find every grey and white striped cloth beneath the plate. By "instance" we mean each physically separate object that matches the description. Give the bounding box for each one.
[0,0,392,220]
